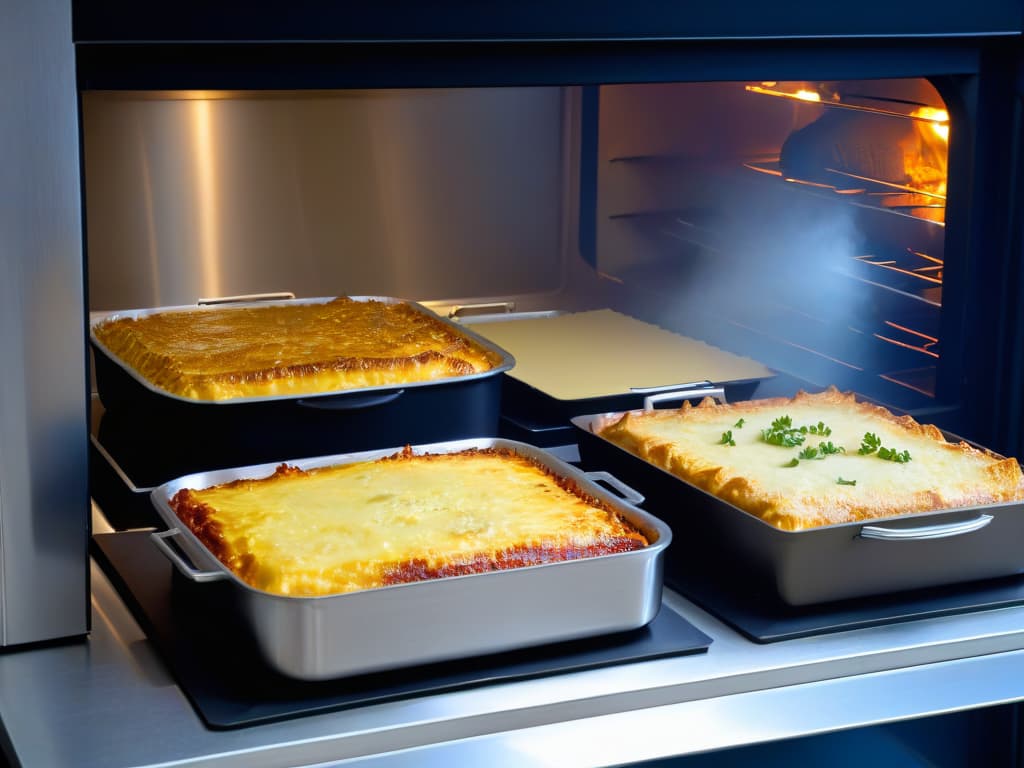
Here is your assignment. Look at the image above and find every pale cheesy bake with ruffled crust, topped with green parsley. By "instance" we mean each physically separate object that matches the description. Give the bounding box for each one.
[594,388,1024,530]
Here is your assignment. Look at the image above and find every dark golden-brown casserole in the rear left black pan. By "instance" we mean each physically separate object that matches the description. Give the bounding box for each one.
[93,297,501,400]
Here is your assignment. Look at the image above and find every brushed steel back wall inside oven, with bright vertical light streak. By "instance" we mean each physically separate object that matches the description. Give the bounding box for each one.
[82,88,566,309]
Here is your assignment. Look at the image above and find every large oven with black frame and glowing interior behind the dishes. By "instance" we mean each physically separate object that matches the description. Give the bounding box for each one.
[70,5,1021,454]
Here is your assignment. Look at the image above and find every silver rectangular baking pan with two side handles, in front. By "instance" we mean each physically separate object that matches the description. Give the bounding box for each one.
[144,438,672,680]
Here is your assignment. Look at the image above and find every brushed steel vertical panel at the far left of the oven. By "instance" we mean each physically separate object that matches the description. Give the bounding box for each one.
[0,0,89,646]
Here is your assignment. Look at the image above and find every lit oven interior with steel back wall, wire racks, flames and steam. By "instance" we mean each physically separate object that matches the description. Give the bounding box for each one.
[82,78,968,460]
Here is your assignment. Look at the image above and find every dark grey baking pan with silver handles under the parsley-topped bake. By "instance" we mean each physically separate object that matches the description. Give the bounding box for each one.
[572,399,1024,606]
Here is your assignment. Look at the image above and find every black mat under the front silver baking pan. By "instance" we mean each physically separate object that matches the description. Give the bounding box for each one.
[92,531,712,728]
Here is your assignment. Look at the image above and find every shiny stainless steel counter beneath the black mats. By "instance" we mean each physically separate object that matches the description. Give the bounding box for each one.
[0,520,1024,768]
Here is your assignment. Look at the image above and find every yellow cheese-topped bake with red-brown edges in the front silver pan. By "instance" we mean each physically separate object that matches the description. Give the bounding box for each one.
[171,447,648,596]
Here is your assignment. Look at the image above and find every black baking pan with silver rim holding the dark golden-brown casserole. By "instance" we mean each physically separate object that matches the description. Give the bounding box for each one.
[90,296,515,456]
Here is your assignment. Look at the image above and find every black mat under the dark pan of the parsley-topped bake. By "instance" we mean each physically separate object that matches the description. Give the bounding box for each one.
[666,567,1024,643]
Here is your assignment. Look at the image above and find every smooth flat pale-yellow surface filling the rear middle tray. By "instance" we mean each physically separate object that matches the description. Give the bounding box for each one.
[473,309,773,400]
